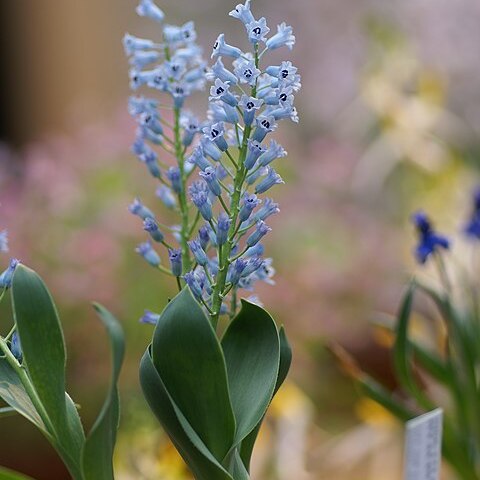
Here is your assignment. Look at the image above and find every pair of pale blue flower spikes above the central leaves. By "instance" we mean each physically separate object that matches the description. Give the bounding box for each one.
[124,0,301,325]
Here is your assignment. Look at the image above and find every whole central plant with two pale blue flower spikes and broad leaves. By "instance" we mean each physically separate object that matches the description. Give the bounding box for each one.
[130,0,300,480]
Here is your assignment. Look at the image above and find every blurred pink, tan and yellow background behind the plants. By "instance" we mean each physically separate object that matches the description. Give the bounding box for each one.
[0,0,480,480]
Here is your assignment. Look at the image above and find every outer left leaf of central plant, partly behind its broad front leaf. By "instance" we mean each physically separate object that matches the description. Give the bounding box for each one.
[140,350,232,480]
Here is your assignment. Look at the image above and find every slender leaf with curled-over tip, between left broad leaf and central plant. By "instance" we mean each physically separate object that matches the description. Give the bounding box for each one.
[83,304,125,480]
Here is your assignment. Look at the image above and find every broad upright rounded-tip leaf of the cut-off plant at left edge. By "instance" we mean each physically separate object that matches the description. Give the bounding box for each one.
[12,265,85,478]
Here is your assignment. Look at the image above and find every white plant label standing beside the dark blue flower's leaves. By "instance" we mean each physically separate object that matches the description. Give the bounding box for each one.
[404,408,443,480]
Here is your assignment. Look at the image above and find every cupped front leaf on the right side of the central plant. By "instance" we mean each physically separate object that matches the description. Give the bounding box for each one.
[222,300,280,446]
